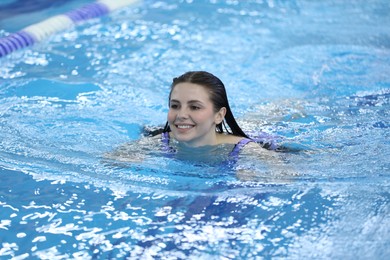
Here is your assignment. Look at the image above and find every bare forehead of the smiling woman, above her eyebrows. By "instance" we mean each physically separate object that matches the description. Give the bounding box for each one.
[171,82,210,101]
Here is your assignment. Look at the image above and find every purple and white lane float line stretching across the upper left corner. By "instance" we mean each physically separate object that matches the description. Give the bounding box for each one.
[0,0,139,58]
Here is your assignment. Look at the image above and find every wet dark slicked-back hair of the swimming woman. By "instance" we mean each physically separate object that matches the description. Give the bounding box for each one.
[163,71,248,138]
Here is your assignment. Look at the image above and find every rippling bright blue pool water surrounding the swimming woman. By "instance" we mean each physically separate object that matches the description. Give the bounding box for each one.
[0,0,390,259]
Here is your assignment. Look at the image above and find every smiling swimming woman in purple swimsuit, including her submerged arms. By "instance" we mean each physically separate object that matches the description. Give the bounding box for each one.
[106,71,295,180]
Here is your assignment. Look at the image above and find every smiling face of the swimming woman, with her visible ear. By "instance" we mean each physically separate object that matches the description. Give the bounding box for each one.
[168,83,226,147]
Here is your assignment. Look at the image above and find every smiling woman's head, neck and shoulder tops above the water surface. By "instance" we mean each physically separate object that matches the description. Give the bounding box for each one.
[157,71,257,155]
